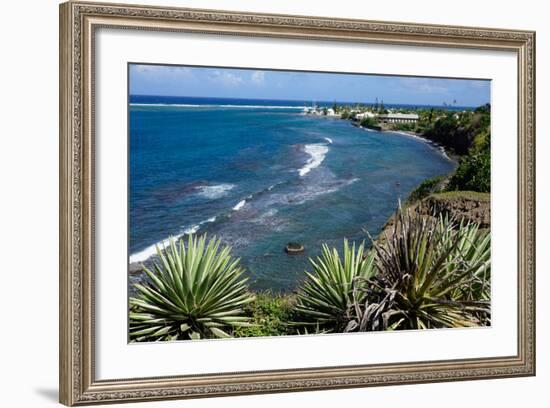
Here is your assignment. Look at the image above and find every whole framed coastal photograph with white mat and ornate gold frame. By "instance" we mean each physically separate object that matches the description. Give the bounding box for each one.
[60,2,535,405]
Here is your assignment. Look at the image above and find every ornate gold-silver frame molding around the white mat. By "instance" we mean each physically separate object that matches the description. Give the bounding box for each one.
[59,2,535,405]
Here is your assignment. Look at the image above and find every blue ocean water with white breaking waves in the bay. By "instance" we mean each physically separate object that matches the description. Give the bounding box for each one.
[128,95,455,292]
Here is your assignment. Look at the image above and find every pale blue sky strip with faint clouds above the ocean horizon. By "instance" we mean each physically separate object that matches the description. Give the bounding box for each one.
[130,64,491,106]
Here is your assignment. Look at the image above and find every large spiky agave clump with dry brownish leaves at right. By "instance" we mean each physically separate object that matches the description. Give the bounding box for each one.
[346,208,490,331]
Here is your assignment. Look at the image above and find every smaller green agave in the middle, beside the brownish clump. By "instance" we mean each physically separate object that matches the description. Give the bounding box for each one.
[295,240,375,332]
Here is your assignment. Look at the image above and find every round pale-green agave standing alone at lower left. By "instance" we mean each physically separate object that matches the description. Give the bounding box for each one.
[130,234,254,341]
